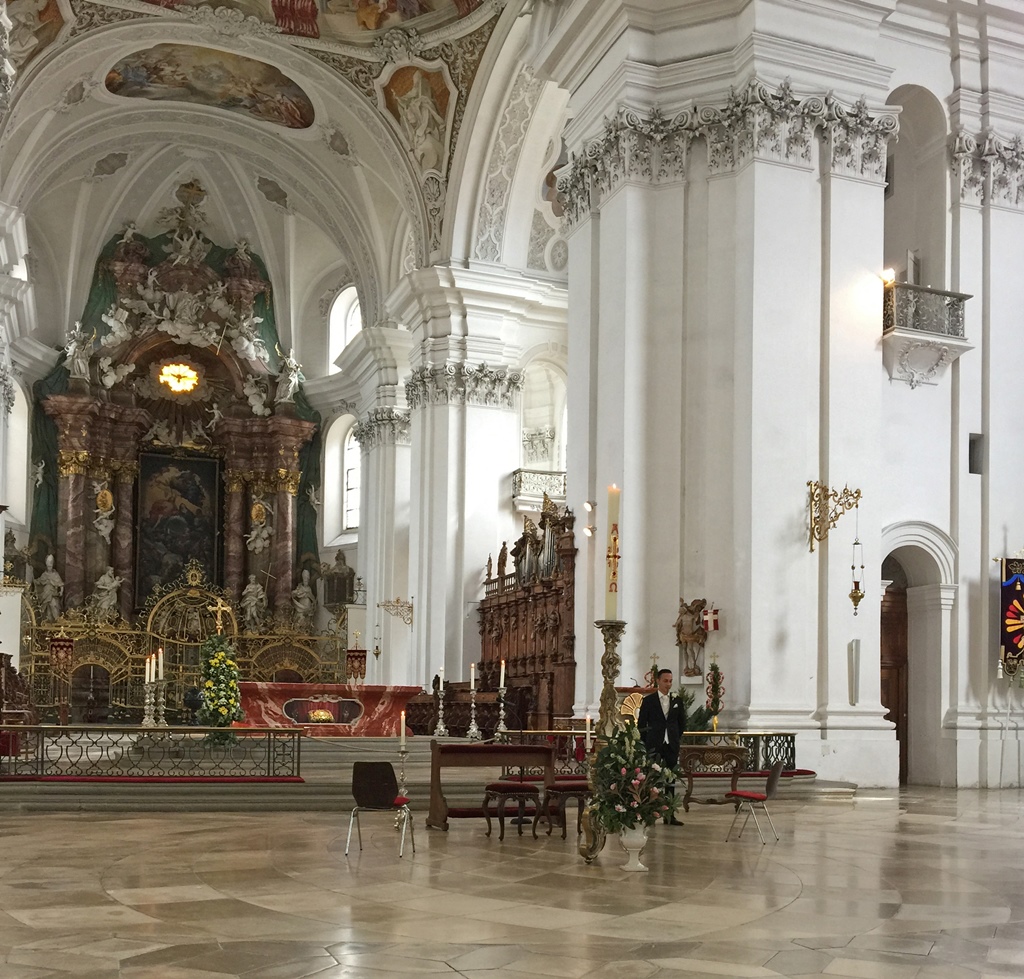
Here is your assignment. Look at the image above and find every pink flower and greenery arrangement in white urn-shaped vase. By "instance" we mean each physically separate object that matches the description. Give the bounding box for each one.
[591,721,678,833]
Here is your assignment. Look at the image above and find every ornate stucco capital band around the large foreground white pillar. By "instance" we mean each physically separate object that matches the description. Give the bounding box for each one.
[558,78,899,227]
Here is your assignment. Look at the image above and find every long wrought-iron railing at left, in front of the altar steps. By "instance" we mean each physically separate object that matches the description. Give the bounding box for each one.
[0,724,302,778]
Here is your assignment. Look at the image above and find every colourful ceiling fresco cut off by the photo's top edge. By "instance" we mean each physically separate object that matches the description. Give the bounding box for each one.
[135,0,483,41]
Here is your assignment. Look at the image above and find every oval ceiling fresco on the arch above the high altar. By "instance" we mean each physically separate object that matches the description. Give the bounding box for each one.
[105,44,313,129]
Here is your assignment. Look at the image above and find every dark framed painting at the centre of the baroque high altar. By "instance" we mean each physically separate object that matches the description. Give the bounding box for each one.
[135,453,220,605]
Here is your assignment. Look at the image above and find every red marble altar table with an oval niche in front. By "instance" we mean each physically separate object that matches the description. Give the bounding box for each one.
[239,681,423,737]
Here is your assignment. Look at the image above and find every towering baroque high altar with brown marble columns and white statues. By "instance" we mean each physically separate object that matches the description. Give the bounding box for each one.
[5,182,358,723]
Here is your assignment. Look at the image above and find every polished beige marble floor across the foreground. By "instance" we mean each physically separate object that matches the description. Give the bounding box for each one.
[0,790,1024,979]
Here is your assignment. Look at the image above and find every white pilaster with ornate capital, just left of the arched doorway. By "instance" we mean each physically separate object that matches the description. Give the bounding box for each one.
[817,102,899,784]
